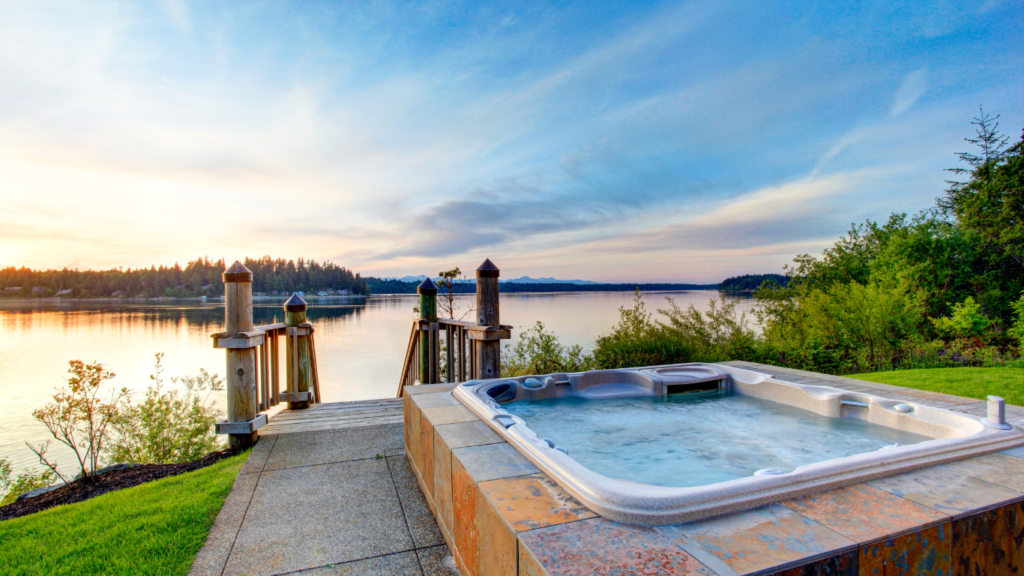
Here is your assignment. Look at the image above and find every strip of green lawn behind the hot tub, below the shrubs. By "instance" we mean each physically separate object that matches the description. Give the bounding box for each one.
[852,368,1024,406]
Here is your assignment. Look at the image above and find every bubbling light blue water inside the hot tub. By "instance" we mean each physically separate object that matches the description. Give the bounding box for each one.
[502,394,931,487]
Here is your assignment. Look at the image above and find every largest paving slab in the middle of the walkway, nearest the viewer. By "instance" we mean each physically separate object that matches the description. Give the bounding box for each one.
[224,458,414,576]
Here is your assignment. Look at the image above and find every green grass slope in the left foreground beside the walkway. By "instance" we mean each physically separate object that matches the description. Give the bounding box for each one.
[0,453,248,576]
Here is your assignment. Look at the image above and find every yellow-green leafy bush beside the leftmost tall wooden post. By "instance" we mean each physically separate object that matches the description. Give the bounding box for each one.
[106,353,224,464]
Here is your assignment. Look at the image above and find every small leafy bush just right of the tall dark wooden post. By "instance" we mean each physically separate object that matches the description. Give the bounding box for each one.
[502,322,594,376]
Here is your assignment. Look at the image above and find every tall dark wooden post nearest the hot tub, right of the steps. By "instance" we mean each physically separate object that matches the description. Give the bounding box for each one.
[469,258,512,378]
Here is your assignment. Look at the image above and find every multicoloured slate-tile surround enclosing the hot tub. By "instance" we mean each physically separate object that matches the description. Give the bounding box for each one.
[404,363,1024,576]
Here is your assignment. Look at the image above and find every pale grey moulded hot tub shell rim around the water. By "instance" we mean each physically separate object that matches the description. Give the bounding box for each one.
[454,364,1024,526]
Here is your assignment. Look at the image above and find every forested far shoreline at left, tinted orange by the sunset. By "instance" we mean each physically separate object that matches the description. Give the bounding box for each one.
[0,256,369,298]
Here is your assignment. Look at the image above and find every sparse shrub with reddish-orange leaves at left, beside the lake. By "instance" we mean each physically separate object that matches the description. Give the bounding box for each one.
[28,360,128,482]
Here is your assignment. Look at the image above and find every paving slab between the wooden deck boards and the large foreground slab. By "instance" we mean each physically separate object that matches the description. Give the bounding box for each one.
[263,423,404,471]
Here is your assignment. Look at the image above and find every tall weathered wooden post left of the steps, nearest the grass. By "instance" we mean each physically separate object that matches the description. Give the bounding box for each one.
[213,261,266,450]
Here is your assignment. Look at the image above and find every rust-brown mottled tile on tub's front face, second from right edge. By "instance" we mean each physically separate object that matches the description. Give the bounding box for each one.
[859,522,952,576]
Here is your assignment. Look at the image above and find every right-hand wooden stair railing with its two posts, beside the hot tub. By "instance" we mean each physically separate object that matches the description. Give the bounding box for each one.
[397,259,512,398]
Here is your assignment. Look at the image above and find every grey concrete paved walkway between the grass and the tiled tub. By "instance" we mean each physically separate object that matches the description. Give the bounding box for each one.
[190,416,458,576]
